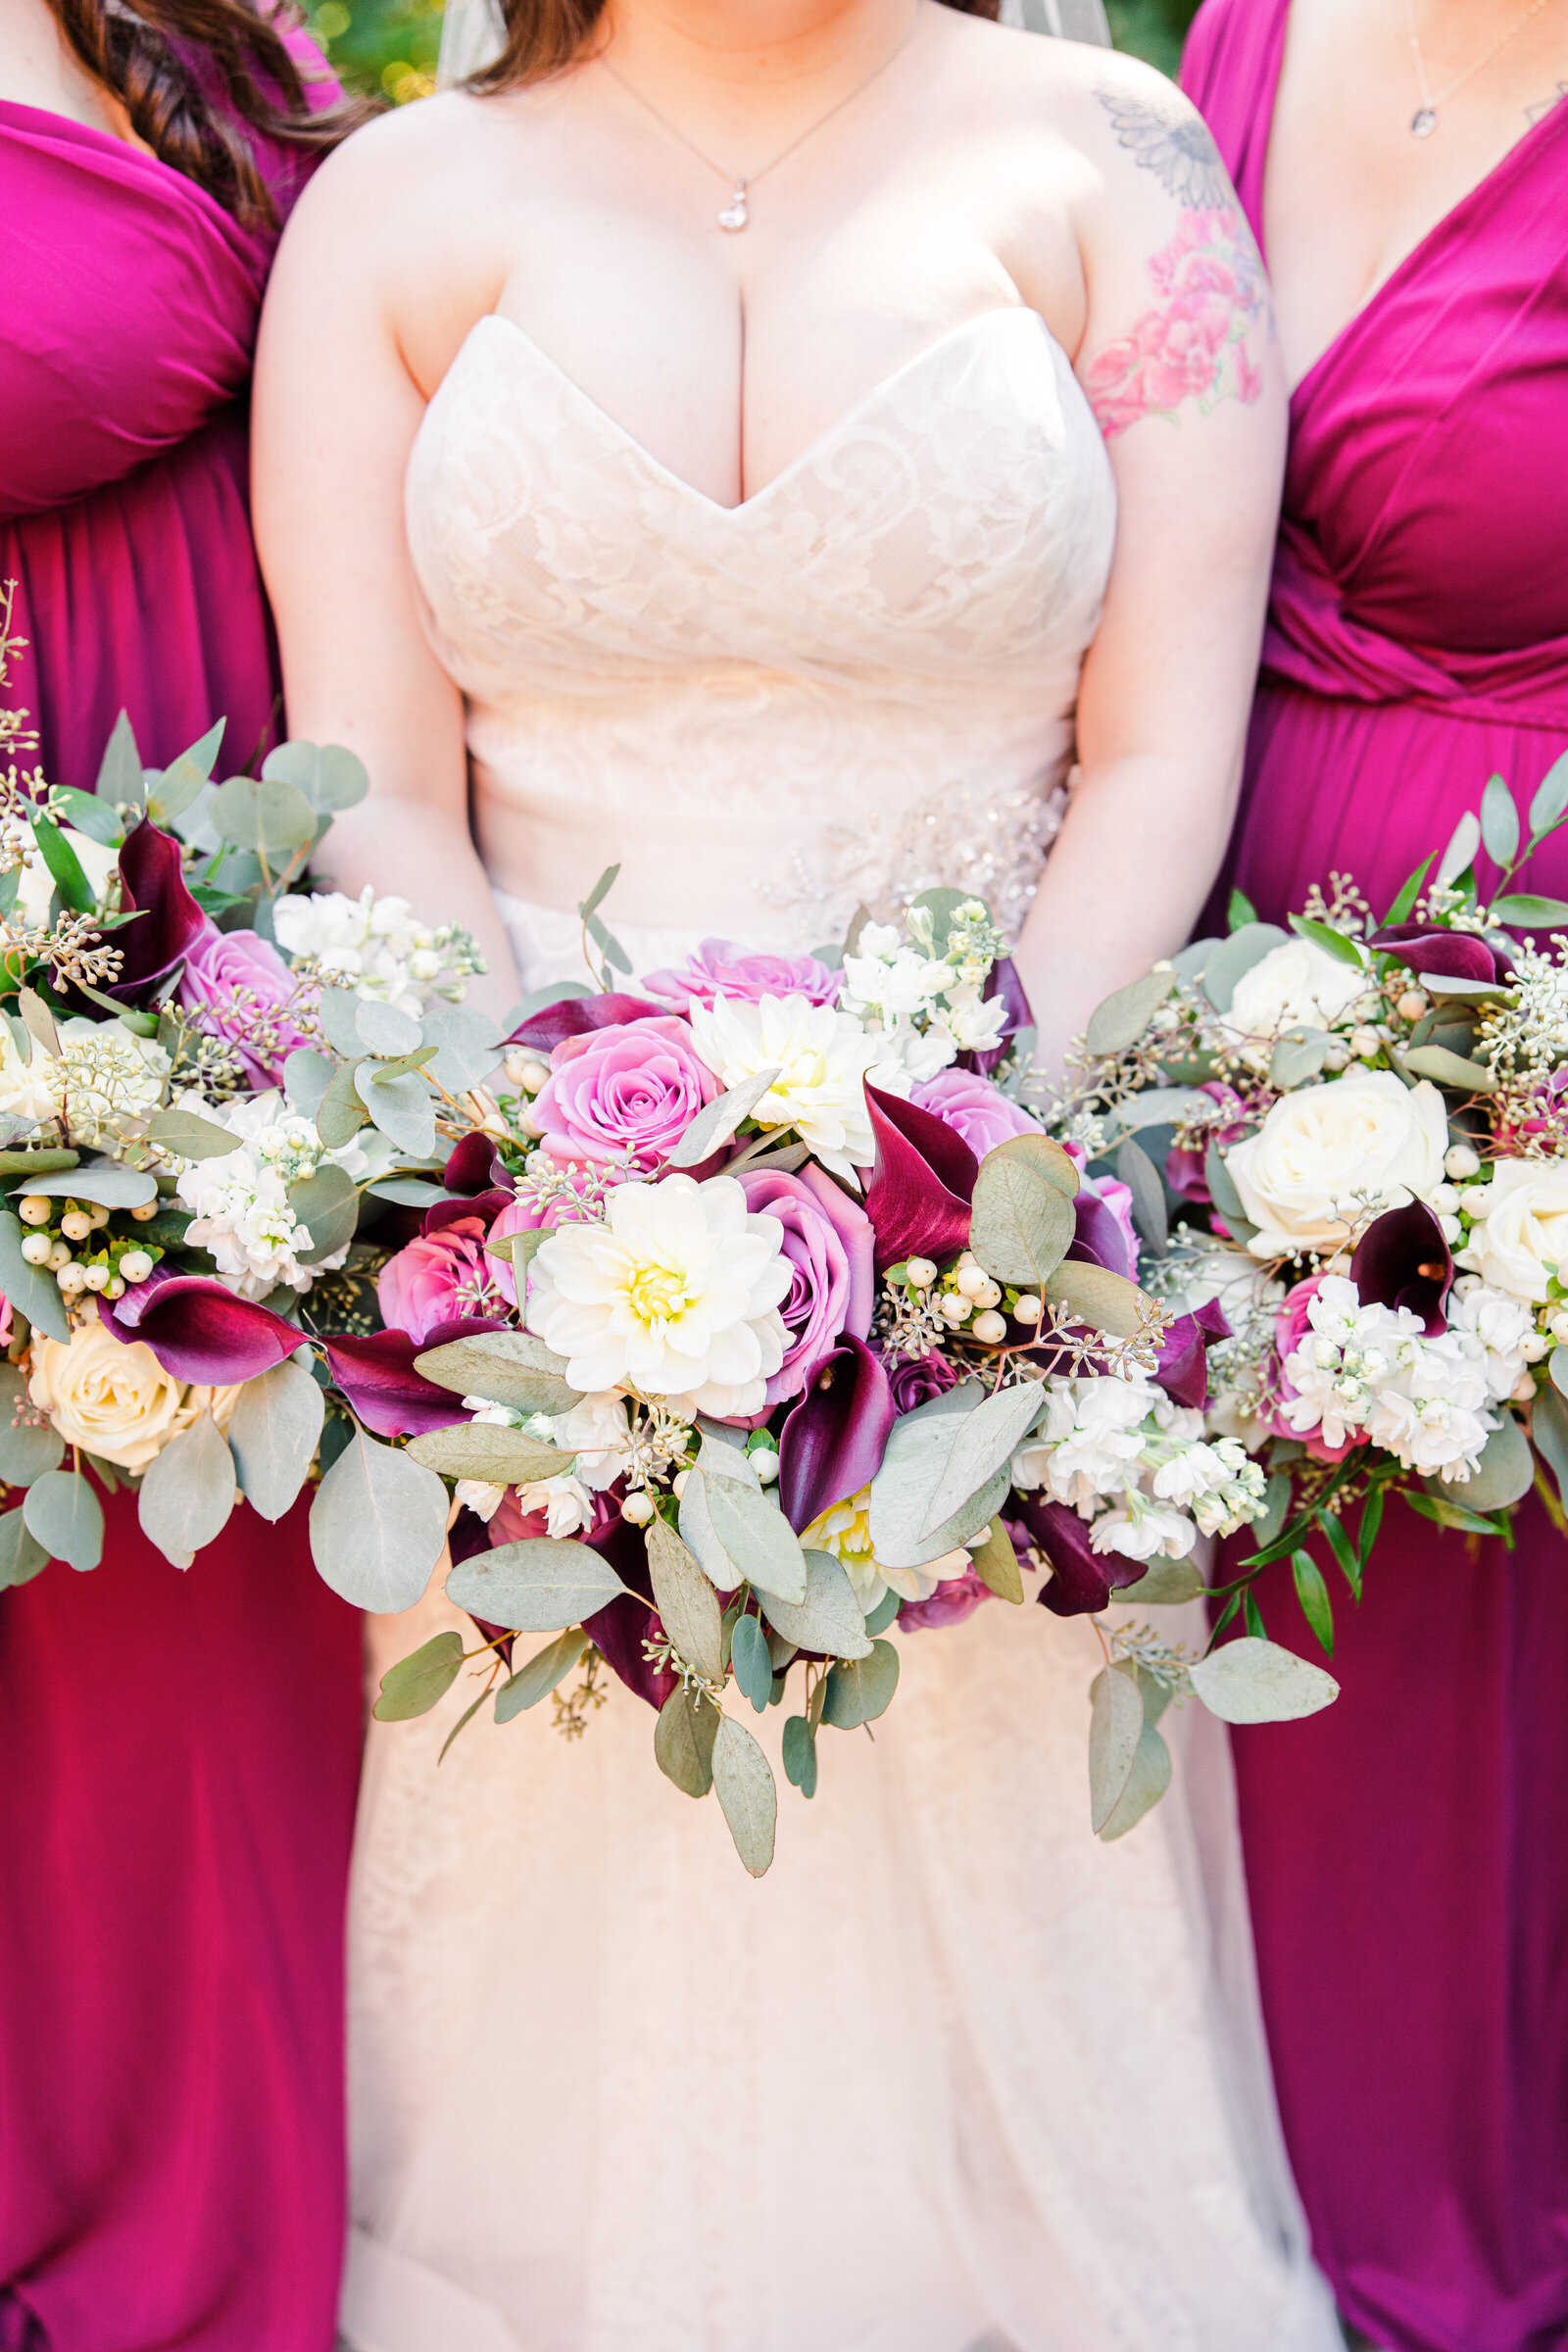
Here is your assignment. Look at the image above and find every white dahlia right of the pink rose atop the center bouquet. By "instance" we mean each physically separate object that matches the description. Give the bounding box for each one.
[686,998,879,1176]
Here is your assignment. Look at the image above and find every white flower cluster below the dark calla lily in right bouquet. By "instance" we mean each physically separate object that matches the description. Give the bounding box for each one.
[1284,1275,1528,1480]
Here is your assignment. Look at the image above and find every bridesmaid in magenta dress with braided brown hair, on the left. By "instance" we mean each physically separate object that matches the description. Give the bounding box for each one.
[0,0,360,2352]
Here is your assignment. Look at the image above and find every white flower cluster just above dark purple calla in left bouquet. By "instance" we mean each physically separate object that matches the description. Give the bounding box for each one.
[175,1086,369,1298]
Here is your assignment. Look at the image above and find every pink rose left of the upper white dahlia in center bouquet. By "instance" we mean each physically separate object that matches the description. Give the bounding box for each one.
[534,1013,719,1174]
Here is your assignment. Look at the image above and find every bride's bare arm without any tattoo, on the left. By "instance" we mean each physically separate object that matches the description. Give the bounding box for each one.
[252,101,517,1013]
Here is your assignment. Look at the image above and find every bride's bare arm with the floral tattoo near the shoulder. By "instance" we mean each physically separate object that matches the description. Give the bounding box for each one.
[1018,59,1286,1068]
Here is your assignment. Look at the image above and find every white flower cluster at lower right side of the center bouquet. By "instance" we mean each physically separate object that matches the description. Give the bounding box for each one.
[1013,1378,1265,1559]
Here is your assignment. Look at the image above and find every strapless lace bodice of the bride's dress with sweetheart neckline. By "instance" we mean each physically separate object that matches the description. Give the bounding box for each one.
[407,311,1116,946]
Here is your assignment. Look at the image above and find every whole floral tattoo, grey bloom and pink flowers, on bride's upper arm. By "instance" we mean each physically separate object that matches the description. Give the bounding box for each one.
[1086,92,1272,440]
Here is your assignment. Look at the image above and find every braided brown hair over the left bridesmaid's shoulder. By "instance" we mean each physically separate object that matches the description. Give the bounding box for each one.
[49,0,371,228]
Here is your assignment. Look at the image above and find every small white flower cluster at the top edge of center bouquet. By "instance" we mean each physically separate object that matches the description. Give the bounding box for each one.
[839,899,1006,1084]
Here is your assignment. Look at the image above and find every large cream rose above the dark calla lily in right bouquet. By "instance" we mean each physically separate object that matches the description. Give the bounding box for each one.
[1225,1070,1448,1256]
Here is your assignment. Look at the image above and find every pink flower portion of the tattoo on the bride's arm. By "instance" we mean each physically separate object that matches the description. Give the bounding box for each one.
[1084,205,1269,440]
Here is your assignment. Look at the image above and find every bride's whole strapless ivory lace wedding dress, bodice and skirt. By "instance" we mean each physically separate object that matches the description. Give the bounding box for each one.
[343,311,1340,2352]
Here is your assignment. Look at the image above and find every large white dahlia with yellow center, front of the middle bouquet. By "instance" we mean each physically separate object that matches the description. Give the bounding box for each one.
[526,1176,792,1416]
